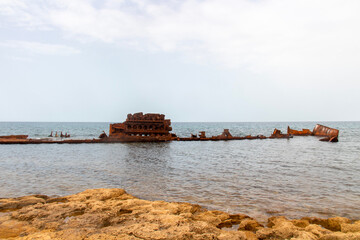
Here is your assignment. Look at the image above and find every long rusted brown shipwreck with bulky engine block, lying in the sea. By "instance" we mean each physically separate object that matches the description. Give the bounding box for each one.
[0,112,339,144]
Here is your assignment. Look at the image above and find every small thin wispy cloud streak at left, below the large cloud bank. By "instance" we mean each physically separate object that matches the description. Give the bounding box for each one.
[0,41,80,56]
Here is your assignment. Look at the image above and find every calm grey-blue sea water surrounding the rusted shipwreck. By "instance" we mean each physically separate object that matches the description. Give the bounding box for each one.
[0,122,360,220]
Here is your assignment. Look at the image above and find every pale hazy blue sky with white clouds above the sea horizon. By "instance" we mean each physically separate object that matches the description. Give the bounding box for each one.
[0,0,360,122]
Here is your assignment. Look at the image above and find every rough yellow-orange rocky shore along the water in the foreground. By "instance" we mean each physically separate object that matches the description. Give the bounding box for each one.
[0,189,360,240]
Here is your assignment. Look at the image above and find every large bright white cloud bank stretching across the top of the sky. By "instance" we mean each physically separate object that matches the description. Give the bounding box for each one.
[0,0,360,77]
